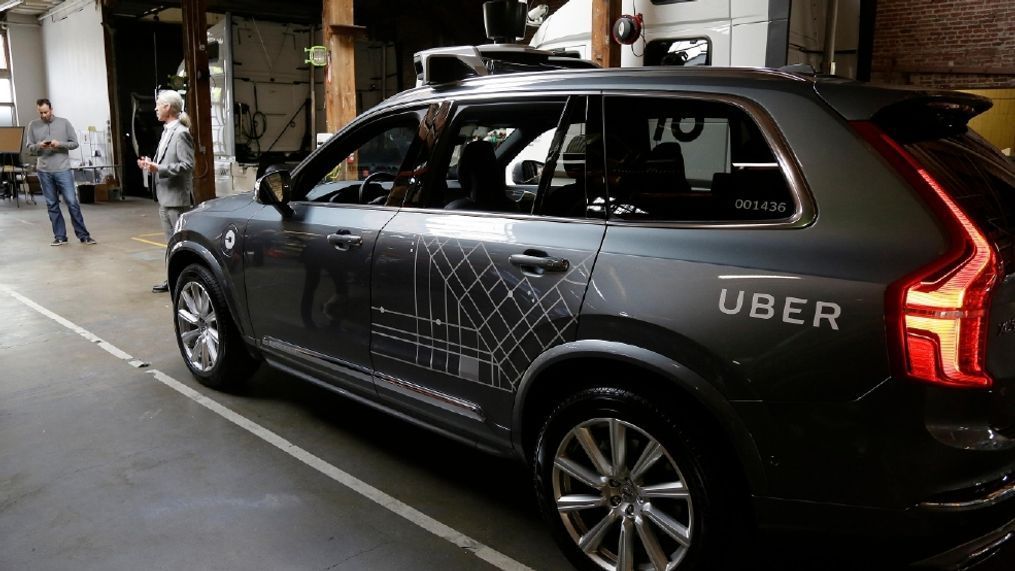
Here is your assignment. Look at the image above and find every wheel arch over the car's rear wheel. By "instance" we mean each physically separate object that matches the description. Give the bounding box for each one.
[513,340,766,493]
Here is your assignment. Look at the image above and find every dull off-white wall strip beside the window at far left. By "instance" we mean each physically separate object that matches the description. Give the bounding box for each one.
[7,13,46,126]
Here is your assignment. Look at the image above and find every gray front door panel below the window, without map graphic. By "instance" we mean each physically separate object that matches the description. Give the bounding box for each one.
[244,202,395,392]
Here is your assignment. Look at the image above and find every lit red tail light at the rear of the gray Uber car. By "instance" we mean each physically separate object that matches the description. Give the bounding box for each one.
[853,122,1001,387]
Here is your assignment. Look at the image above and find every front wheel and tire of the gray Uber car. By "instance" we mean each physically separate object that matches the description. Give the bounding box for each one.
[173,264,259,390]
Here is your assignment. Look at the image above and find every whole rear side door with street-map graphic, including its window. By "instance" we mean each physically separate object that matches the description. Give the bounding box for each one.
[370,96,605,439]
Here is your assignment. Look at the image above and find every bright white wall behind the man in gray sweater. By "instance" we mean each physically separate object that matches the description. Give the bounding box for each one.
[39,0,110,159]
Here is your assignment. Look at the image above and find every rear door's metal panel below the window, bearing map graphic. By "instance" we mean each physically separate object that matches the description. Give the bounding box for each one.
[370,210,605,440]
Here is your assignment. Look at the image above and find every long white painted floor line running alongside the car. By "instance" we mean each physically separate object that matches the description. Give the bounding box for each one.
[0,286,530,571]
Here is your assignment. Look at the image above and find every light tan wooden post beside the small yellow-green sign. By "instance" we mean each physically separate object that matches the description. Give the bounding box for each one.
[322,0,361,133]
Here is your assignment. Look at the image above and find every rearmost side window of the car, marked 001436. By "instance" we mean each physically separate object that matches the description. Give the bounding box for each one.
[604,97,797,222]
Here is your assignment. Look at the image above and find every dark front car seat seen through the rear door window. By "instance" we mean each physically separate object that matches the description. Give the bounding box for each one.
[445,141,517,212]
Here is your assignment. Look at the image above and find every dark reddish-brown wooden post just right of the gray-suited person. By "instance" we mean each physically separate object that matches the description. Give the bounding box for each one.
[183,0,215,204]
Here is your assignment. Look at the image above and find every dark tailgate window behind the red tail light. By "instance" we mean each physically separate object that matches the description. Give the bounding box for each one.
[903,131,1015,265]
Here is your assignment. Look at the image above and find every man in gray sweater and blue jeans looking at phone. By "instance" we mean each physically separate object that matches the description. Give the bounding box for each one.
[28,98,95,245]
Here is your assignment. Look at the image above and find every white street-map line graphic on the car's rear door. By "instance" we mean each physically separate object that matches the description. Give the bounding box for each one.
[370,236,596,390]
